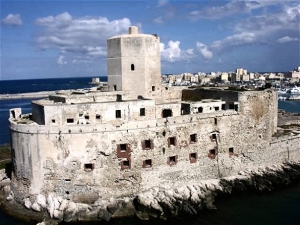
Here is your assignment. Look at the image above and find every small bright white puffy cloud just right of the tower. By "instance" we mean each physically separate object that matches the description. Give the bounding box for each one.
[160,40,195,62]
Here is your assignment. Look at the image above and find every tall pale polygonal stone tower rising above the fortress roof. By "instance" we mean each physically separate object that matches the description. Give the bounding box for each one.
[107,26,161,98]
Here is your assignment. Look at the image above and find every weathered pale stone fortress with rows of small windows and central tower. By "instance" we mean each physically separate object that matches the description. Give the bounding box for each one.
[9,26,300,221]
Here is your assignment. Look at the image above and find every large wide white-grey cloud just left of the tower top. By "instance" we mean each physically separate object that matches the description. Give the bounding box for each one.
[35,12,131,62]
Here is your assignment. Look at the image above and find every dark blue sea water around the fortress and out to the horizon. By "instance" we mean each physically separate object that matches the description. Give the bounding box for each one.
[0,77,300,225]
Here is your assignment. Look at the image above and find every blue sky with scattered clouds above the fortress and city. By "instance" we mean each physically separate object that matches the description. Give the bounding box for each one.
[0,0,300,80]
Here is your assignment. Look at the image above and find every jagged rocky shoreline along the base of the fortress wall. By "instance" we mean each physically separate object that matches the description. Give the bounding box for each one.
[0,162,300,224]
